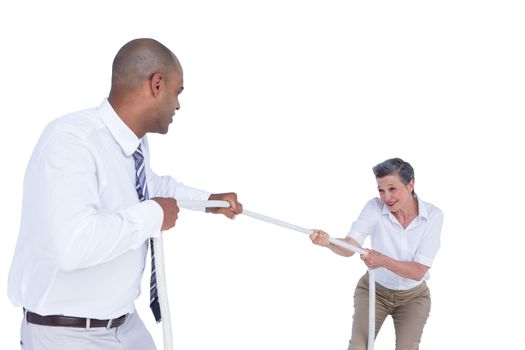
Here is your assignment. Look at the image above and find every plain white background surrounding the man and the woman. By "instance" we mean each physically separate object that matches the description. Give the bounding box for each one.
[0,0,525,350]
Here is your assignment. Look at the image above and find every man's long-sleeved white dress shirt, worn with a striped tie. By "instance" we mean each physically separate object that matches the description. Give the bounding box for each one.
[8,99,210,319]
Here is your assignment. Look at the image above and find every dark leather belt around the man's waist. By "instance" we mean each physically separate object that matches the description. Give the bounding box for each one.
[26,311,127,328]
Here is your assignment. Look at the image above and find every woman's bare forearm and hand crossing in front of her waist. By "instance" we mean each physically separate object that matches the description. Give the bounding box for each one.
[361,249,429,281]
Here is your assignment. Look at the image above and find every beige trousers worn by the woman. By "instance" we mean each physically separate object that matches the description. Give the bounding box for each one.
[348,273,431,350]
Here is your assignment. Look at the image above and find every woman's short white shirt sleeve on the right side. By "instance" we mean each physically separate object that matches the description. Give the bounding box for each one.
[414,207,443,267]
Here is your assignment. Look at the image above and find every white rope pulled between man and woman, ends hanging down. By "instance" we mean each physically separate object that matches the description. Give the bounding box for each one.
[153,200,376,350]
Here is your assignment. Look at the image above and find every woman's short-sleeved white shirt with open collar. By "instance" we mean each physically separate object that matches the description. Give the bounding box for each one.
[347,198,443,290]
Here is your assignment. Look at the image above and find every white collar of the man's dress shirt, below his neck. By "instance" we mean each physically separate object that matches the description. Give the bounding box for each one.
[98,98,141,157]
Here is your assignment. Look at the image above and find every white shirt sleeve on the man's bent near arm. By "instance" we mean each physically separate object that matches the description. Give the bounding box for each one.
[37,132,163,271]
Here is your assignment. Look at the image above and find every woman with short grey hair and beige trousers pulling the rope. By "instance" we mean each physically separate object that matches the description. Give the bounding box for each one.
[310,158,443,350]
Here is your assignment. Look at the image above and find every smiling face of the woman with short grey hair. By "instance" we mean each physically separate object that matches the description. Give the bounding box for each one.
[376,174,414,213]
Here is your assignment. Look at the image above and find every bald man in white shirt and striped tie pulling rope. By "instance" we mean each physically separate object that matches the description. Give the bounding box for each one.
[8,39,242,350]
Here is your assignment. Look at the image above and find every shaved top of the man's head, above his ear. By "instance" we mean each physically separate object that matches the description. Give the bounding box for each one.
[111,39,182,93]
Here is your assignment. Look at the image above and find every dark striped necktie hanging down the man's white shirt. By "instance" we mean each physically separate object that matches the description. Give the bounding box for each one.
[133,145,161,322]
